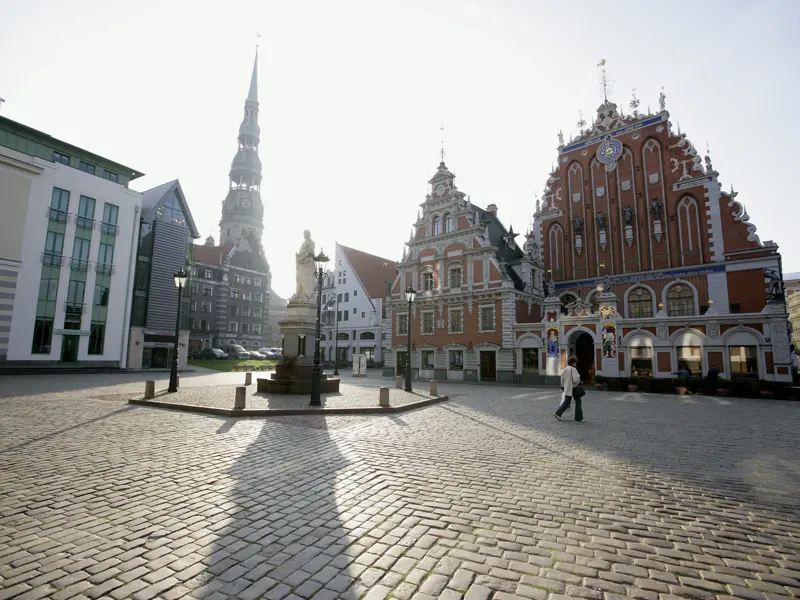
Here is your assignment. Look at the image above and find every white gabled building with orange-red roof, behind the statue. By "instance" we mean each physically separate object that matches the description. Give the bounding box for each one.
[320,243,397,364]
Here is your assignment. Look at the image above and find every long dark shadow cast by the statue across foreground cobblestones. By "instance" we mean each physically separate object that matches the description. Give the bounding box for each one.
[183,415,388,600]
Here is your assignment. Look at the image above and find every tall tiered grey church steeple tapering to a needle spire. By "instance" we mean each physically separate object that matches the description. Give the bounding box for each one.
[219,50,264,244]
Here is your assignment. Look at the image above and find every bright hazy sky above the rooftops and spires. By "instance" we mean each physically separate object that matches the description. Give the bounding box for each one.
[0,0,800,297]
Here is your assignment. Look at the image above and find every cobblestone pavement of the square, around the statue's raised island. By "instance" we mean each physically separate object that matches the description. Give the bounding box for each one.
[0,376,800,600]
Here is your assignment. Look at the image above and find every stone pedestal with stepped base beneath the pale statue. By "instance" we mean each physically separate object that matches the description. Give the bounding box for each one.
[257,300,339,394]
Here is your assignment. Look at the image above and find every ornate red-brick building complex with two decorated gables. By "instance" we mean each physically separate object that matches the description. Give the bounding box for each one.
[383,95,791,383]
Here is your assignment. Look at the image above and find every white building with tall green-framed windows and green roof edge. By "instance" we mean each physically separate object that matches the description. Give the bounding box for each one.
[0,112,142,367]
